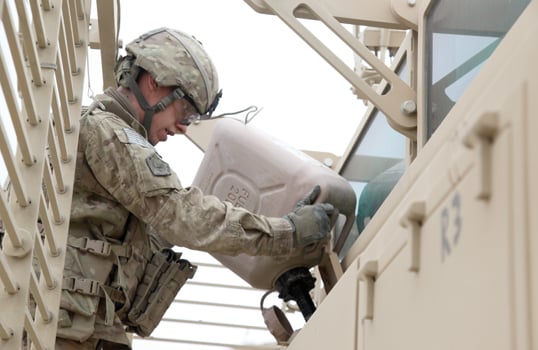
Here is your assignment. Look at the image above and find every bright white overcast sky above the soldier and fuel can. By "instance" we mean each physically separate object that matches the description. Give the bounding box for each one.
[90,0,364,185]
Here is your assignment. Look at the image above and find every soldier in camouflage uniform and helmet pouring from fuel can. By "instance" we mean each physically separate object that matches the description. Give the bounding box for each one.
[56,28,333,349]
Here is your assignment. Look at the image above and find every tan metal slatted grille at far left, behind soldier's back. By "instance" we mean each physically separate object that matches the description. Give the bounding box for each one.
[0,0,91,350]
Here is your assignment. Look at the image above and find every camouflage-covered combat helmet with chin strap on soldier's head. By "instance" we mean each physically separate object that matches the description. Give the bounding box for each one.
[115,28,222,133]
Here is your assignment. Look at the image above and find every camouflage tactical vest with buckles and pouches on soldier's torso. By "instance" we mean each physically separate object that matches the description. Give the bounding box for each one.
[57,95,196,344]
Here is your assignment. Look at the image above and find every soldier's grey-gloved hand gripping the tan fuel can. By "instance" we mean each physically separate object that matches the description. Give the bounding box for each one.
[284,186,334,249]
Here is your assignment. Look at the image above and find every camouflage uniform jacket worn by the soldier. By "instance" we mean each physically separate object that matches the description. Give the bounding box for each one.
[58,89,292,340]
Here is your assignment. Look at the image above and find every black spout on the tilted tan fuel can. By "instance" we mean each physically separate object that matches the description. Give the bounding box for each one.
[275,267,316,321]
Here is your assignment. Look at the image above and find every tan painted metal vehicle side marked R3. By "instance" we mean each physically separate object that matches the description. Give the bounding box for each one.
[247,0,538,349]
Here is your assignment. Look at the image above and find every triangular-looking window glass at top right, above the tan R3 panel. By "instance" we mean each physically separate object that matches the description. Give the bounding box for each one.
[425,0,530,138]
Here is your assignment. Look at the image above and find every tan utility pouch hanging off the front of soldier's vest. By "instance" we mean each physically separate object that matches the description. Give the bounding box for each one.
[126,248,197,337]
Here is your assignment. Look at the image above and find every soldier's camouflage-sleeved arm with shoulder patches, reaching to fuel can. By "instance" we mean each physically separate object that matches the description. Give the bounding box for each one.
[85,119,293,255]
